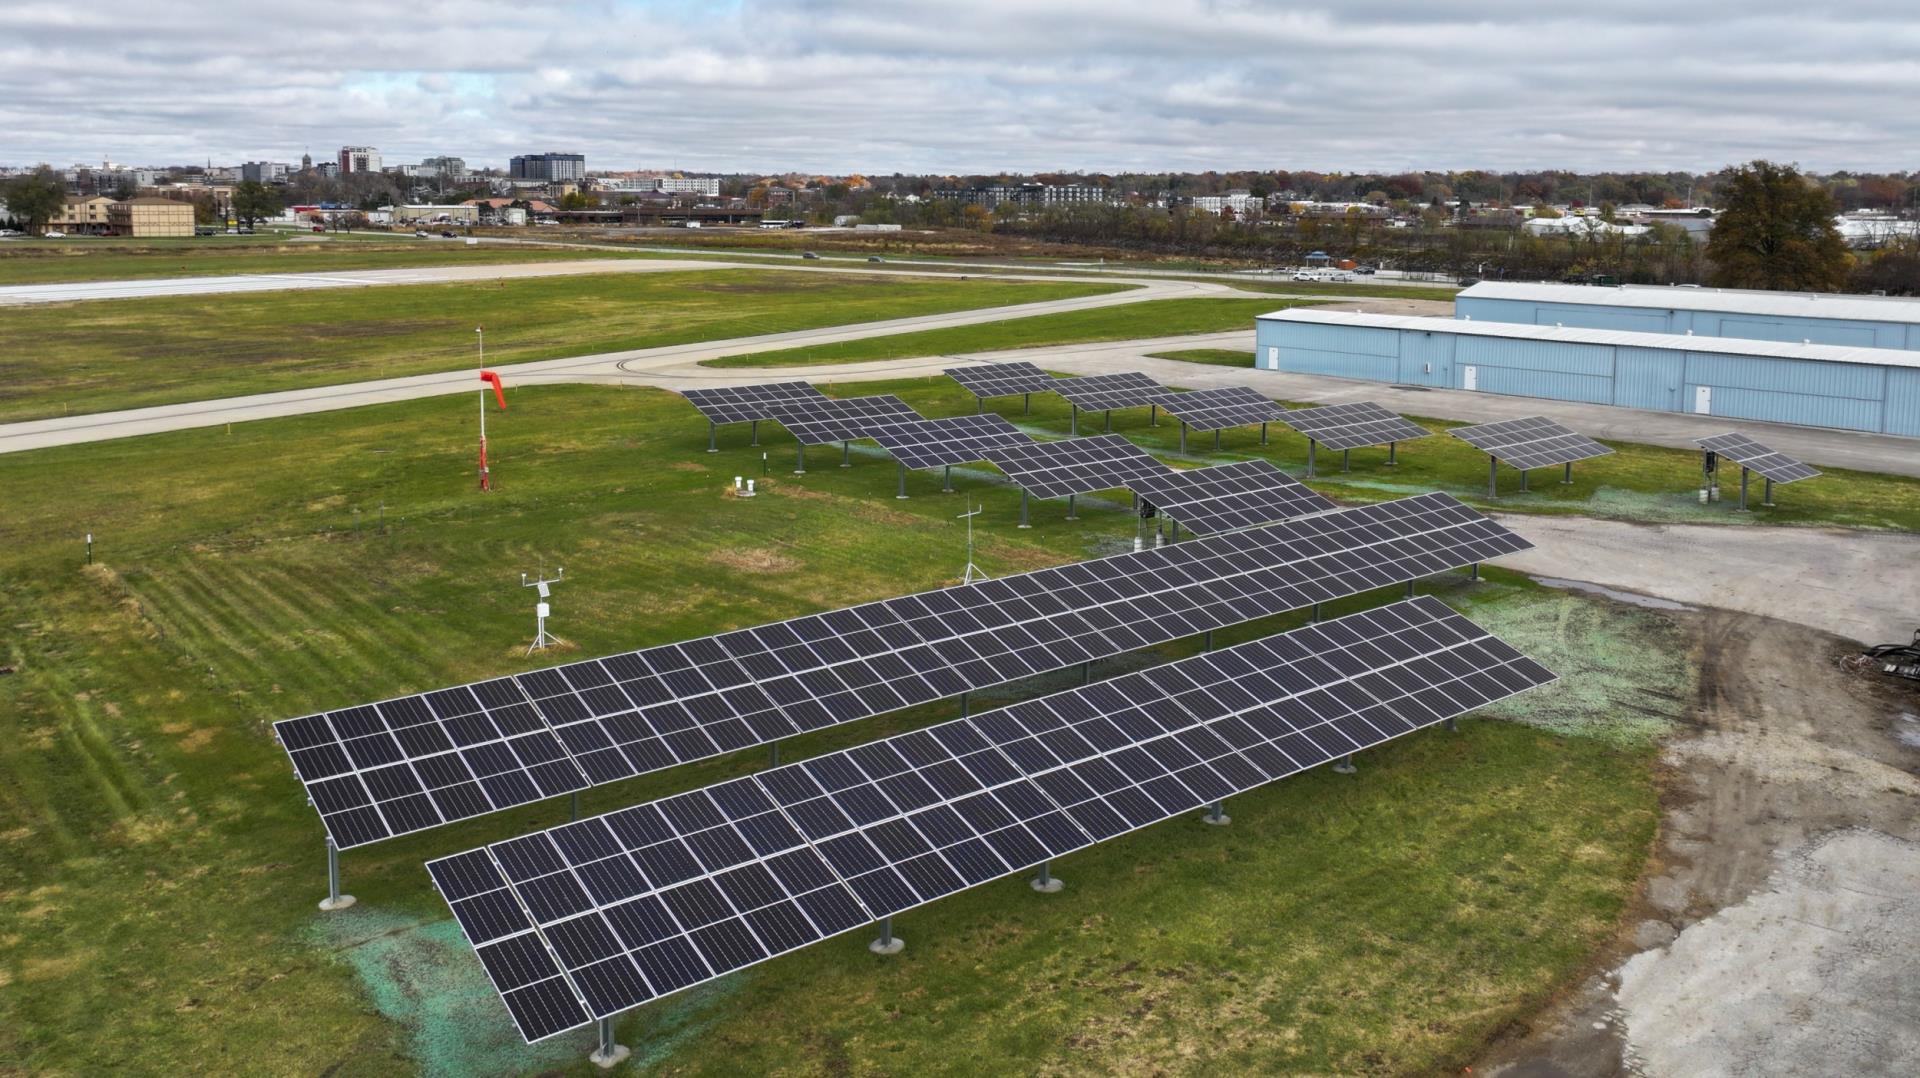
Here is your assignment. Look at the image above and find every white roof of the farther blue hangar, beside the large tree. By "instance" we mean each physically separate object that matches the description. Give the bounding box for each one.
[1457,281,1920,325]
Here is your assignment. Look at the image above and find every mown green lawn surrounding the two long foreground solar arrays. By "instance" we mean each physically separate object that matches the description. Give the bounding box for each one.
[0,380,1666,1076]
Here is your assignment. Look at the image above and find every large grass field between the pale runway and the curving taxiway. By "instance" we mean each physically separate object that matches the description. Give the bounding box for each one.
[0,269,1125,423]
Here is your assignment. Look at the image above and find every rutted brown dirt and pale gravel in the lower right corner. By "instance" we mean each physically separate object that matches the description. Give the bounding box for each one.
[1473,611,1920,1078]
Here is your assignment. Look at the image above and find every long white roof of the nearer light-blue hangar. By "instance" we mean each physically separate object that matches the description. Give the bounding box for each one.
[1258,307,1920,369]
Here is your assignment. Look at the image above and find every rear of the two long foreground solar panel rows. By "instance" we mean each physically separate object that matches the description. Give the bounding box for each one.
[275,494,1530,849]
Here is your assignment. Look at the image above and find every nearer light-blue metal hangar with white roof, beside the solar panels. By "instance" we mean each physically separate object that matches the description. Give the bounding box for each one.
[1254,307,1920,438]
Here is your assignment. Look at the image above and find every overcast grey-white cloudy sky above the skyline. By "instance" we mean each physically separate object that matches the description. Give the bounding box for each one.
[0,0,1920,173]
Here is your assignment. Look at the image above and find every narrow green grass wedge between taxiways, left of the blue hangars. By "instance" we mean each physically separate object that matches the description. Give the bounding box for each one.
[701,298,1308,367]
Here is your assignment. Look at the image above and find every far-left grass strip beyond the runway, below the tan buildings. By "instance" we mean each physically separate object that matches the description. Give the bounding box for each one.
[0,233,659,284]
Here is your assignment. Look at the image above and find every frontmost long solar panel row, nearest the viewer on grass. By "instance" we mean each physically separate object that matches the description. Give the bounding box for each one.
[426,598,1553,1041]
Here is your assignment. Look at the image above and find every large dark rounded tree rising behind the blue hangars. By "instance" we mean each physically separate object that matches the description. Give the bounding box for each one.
[1707,161,1851,292]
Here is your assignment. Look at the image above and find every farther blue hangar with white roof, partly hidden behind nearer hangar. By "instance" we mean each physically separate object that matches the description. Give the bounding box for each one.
[1453,281,1920,350]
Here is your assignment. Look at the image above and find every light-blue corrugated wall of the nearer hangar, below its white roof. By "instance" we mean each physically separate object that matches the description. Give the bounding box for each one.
[1256,321,1920,436]
